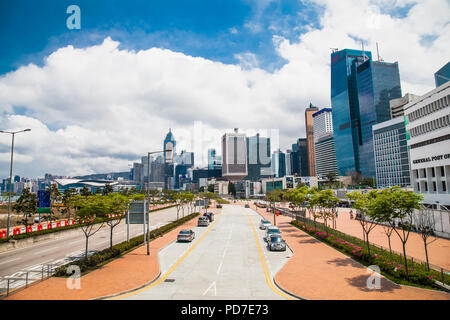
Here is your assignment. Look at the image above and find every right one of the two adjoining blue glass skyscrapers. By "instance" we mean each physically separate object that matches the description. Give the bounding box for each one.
[356,60,402,178]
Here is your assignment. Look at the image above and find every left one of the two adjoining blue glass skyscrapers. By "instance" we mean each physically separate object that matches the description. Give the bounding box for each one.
[331,49,372,176]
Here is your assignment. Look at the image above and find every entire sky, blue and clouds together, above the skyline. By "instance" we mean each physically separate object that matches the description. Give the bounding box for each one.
[0,0,450,178]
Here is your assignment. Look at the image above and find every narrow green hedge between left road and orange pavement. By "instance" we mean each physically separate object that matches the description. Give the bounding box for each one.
[55,212,199,277]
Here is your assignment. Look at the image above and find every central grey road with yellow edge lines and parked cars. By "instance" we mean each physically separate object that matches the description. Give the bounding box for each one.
[113,205,292,300]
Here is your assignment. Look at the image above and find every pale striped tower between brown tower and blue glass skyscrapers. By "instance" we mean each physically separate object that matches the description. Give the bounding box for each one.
[313,108,337,177]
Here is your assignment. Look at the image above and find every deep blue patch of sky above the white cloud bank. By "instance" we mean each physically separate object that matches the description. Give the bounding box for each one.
[0,0,320,74]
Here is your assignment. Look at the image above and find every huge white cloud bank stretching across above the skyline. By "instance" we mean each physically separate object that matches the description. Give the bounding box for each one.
[0,0,450,177]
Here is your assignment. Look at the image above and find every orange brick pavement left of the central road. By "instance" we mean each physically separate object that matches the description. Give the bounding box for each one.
[4,211,197,300]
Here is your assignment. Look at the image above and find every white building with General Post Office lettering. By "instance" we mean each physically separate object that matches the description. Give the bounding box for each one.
[405,82,450,210]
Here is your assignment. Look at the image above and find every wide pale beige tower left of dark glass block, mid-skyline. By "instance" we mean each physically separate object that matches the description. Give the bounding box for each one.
[222,129,248,181]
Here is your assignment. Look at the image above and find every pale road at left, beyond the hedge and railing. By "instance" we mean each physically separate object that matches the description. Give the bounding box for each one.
[0,208,185,277]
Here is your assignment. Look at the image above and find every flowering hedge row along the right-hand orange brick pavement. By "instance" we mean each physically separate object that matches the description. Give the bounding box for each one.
[291,220,450,290]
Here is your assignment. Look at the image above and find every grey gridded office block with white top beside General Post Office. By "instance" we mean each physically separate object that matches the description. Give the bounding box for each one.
[372,116,411,188]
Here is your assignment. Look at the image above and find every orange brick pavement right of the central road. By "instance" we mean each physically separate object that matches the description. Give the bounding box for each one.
[251,204,450,300]
